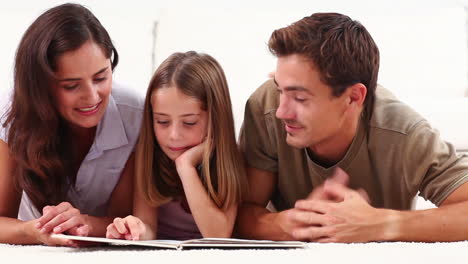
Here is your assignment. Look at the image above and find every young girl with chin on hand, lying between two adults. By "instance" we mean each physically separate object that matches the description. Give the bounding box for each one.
[106,51,245,240]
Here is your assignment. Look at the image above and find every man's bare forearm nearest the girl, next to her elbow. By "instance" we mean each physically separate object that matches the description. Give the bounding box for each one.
[236,203,294,240]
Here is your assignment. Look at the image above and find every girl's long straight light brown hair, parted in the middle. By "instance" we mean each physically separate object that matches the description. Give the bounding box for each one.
[135,51,246,209]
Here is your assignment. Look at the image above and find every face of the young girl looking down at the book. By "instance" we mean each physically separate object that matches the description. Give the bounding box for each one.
[151,87,208,160]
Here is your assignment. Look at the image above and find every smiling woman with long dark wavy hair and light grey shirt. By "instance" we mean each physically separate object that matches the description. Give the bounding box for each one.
[0,4,143,245]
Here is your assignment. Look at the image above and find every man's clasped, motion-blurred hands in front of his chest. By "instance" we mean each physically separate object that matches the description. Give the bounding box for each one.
[292,176,391,243]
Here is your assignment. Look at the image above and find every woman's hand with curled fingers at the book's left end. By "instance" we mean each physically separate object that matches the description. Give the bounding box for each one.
[34,202,90,236]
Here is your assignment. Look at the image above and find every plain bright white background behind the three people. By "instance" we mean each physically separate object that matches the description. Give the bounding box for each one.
[0,0,468,208]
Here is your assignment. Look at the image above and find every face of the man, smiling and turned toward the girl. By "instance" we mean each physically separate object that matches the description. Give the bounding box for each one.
[275,54,348,149]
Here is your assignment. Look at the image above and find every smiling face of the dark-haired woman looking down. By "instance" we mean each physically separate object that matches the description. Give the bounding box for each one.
[52,41,112,128]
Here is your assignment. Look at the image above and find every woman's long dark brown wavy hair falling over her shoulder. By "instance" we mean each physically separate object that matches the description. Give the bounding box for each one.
[2,4,118,210]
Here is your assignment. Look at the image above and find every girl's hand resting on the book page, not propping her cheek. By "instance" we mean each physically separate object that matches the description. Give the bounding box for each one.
[106,215,147,240]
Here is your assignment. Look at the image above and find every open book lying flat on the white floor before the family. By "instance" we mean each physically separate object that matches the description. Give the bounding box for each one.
[52,234,307,250]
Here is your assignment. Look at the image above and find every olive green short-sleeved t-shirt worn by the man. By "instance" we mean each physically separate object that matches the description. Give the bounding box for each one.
[240,80,468,210]
